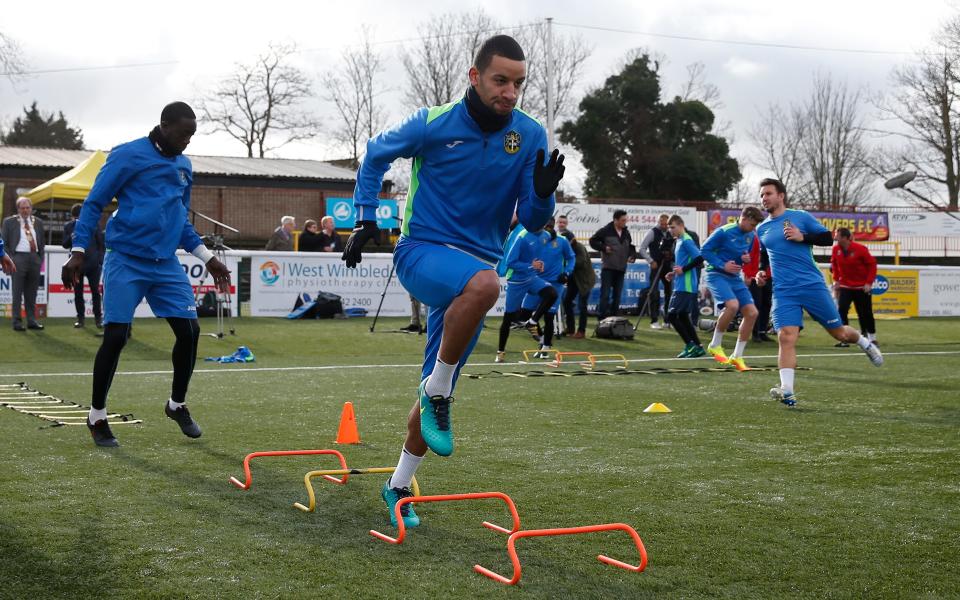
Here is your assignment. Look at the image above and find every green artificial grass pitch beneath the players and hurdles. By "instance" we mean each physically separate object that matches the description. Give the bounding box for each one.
[0,319,960,599]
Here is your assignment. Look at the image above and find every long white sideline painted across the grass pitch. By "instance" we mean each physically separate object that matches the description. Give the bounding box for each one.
[0,350,960,379]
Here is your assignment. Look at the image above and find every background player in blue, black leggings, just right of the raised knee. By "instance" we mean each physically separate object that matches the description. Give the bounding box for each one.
[496,225,558,362]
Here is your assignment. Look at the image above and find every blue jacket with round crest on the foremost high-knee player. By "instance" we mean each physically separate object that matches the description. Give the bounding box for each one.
[353,98,554,264]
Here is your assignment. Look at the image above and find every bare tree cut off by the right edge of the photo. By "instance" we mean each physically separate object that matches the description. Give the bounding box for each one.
[873,16,960,211]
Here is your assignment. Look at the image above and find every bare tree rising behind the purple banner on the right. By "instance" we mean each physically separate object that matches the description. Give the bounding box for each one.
[749,75,875,210]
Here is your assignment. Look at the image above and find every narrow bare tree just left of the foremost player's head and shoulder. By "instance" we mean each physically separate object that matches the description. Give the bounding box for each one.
[323,27,386,167]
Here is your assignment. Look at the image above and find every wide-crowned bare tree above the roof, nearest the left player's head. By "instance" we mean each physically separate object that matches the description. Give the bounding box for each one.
[199,43,320,158]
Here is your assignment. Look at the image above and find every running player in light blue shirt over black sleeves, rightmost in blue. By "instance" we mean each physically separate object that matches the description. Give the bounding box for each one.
[757,179,883,406]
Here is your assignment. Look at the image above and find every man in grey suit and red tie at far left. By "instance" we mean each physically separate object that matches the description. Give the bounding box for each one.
[3,197,44,331]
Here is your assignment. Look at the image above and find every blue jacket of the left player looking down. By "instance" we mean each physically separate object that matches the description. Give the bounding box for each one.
[73,137,203,260]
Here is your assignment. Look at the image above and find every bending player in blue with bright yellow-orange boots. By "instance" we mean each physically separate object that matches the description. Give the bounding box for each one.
[700,206,763,371]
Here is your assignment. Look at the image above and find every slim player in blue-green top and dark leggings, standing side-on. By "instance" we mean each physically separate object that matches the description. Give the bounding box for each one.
[667,215,707,358]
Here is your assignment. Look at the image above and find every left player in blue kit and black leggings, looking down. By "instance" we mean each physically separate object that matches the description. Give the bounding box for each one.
[61,102,230,446]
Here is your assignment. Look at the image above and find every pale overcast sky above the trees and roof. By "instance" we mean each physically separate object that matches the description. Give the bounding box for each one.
[0,0,957,193]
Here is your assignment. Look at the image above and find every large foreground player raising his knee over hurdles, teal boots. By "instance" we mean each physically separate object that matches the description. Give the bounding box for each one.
[343,35,563,527]
